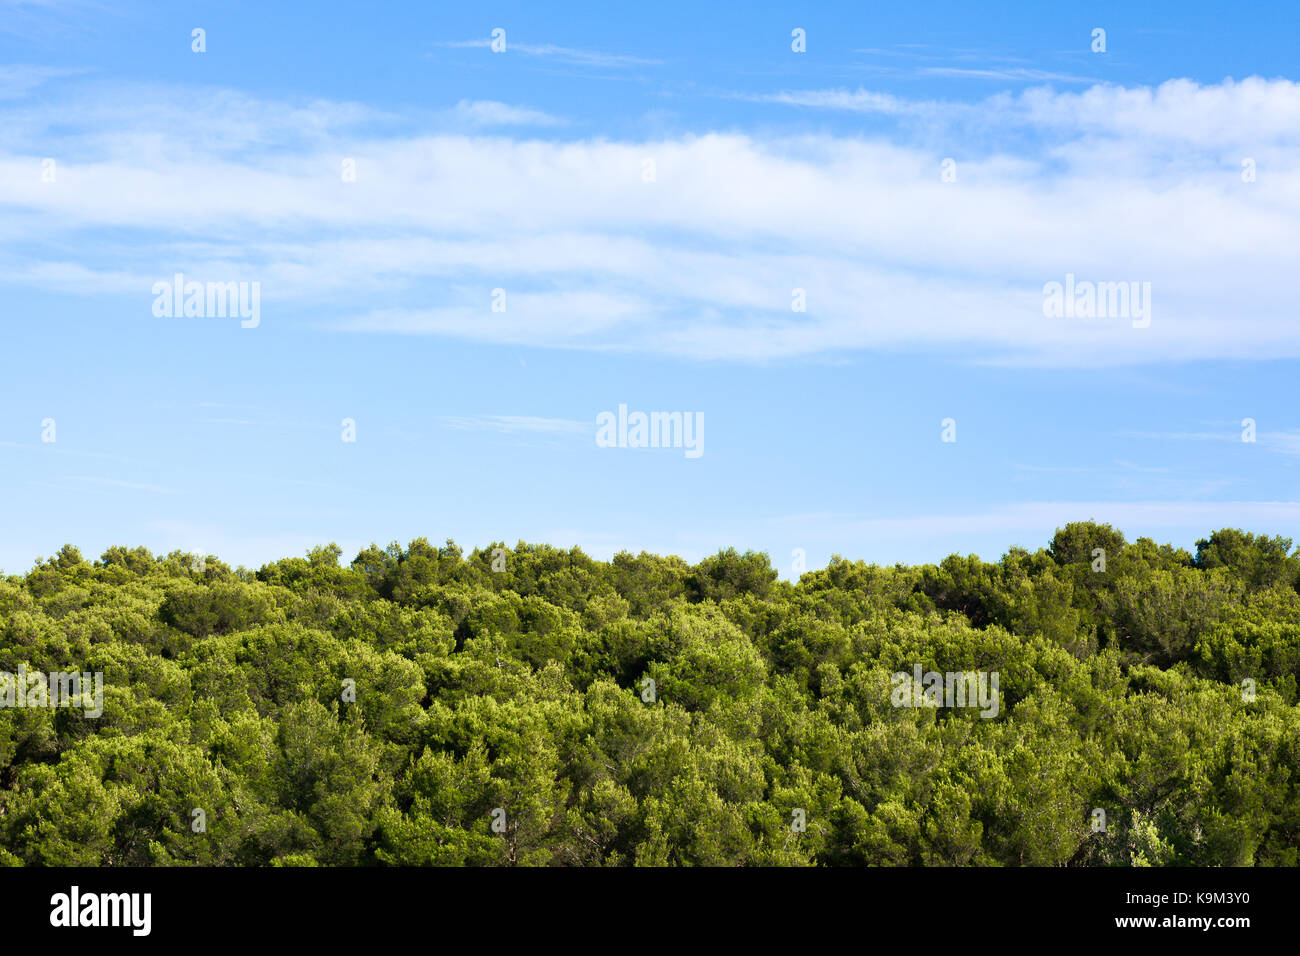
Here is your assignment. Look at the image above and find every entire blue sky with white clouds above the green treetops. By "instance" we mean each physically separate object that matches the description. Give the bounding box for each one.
[0,0,1300,574]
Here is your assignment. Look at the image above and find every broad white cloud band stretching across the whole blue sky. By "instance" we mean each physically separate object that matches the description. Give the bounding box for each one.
[0,73,1300,365]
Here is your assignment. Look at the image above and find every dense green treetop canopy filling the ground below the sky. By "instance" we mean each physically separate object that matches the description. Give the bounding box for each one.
[0,523,1300,865]
